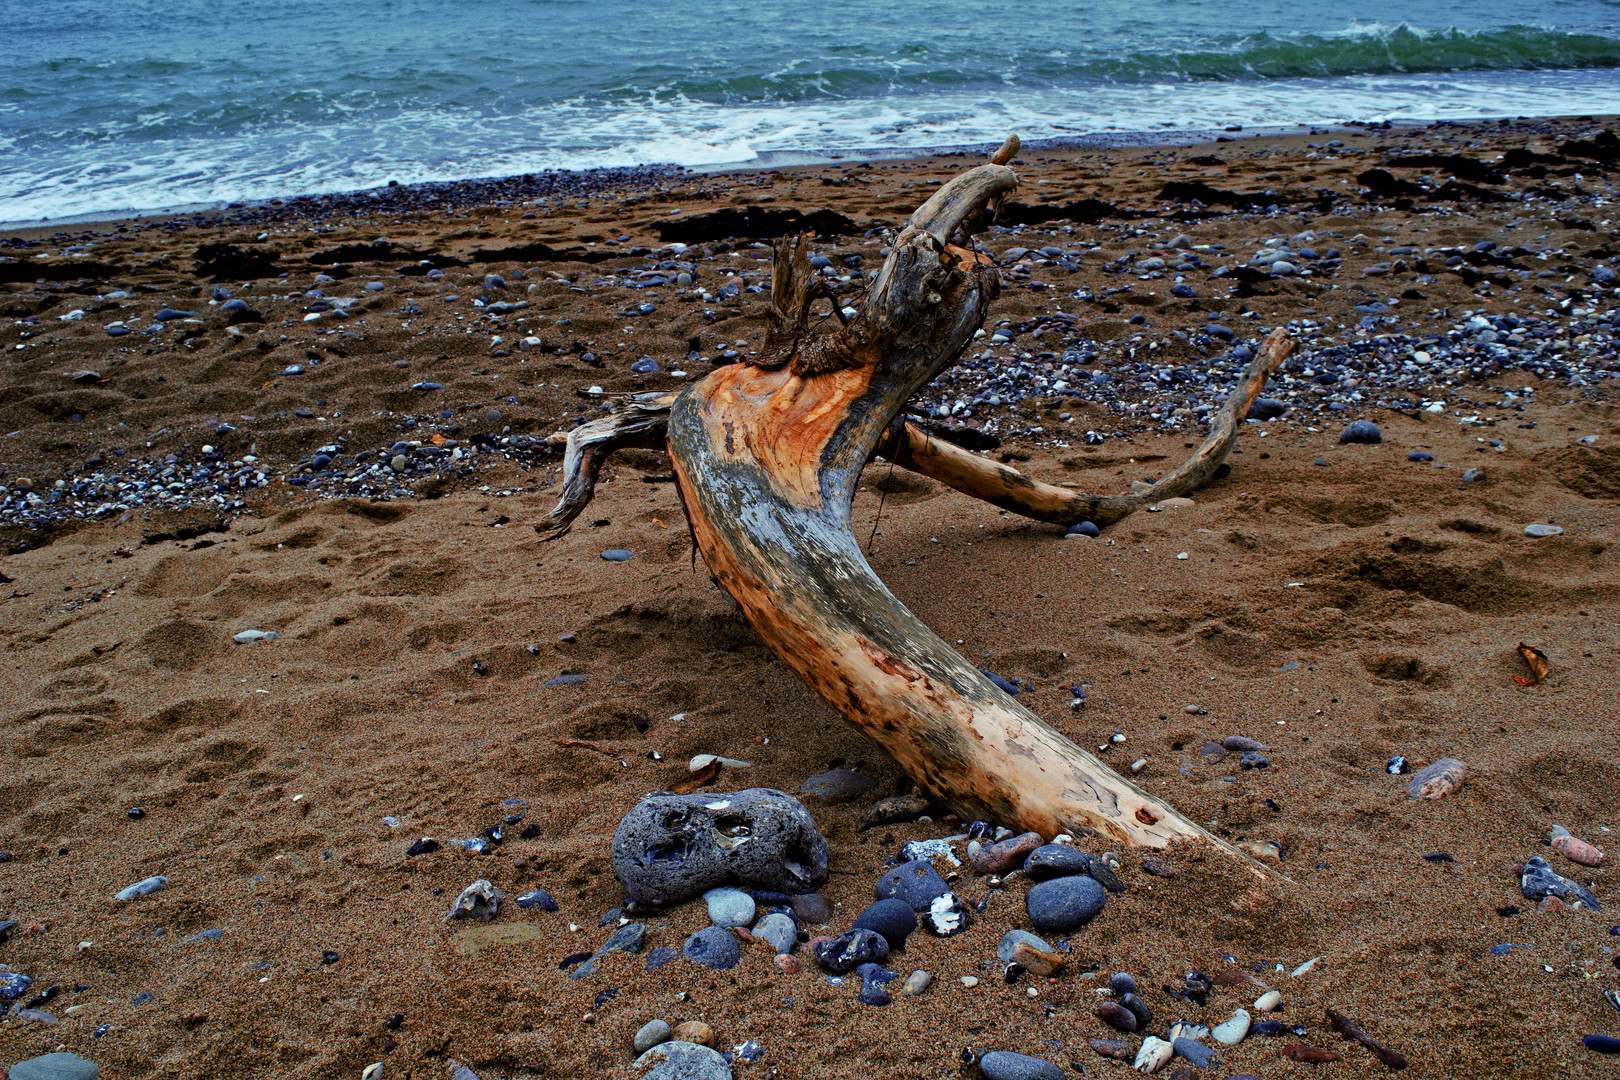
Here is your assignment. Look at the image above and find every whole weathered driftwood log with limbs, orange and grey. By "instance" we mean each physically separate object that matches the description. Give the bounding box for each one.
[536,139,1291,873]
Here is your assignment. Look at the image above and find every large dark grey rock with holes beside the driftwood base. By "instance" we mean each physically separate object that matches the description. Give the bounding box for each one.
[612,787,826,907]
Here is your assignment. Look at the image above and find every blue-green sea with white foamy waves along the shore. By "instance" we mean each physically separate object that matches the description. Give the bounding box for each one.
[0,0,1620,222]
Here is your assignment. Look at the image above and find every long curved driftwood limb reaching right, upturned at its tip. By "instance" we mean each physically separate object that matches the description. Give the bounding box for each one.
[878,327,1294,526]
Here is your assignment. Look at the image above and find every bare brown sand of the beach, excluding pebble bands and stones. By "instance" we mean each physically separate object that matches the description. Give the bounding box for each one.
[0,125,1620,1080]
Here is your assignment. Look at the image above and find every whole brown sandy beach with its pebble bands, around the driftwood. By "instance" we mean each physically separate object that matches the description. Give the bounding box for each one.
[0,118,1620,1080]
